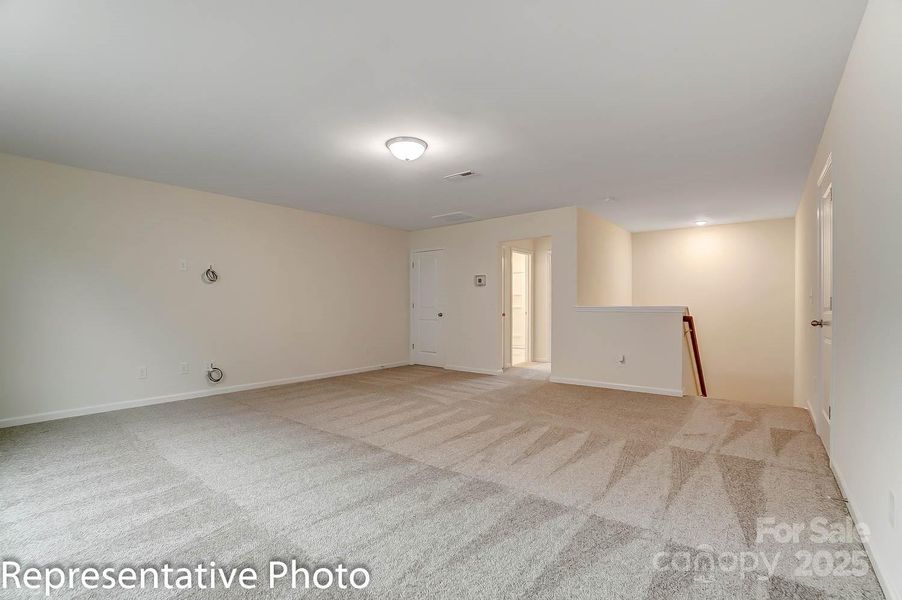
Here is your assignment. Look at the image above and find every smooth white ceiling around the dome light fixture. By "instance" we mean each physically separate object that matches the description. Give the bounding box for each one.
[0,0,865,231]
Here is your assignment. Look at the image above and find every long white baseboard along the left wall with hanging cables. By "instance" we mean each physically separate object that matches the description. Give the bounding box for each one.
[0,360,410,429]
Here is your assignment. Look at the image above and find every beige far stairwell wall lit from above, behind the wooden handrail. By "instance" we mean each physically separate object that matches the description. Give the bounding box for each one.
[633,219,795,406]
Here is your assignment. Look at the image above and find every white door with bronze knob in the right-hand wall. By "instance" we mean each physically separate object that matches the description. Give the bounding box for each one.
[811,163,833,454]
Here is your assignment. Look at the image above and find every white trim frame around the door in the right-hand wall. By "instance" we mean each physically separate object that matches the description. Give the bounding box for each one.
[809,153,836,457]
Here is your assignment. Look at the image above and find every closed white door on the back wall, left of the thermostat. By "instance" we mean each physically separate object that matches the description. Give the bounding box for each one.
[410,250,445,367]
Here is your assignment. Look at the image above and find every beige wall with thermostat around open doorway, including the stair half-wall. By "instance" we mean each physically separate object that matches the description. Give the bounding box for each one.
[410,208,682,394]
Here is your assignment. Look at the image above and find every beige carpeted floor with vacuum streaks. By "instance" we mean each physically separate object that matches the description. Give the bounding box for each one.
[0,367,883,599]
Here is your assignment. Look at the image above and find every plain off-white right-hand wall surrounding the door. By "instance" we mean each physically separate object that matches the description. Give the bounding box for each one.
[796,0,902,599]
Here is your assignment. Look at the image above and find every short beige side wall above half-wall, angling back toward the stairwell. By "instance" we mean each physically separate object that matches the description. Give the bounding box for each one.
[577,208,633,306]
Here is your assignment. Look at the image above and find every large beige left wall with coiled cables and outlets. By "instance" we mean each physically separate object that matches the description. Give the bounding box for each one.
[0,155,408,419]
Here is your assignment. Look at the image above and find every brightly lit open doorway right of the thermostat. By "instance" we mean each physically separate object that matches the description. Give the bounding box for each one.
[501,237,551,372]
